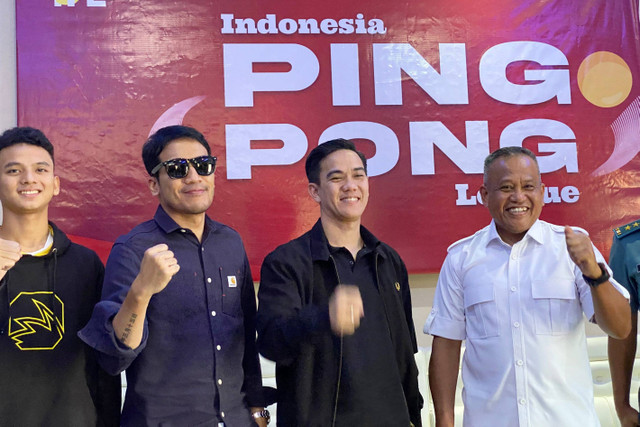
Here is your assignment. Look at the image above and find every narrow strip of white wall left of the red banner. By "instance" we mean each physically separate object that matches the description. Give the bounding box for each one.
[0,0,18,130]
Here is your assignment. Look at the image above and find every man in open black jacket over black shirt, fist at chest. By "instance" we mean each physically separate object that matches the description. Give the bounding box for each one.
[257,139,422,427]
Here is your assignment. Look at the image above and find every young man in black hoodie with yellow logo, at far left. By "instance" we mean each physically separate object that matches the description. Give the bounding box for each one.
[0,127,121,427]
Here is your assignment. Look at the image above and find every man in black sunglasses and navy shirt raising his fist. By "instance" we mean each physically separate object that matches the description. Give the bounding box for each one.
[80,126,268,427]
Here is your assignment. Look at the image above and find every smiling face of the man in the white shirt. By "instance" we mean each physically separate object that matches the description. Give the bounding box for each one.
[480,154,544,245]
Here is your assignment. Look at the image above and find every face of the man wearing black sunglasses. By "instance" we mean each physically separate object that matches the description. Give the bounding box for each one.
[149,138,215,225]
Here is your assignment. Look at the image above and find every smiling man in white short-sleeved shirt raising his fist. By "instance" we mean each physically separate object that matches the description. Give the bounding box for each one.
[424,147,631,427]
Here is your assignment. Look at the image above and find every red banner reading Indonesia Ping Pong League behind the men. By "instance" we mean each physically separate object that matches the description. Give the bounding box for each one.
[16,0,640,275]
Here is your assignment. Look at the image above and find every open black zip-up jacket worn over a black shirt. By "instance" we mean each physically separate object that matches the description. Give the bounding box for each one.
[257,220,422,427]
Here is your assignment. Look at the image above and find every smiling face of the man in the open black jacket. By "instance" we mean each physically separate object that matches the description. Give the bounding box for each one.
[309,150,369,227]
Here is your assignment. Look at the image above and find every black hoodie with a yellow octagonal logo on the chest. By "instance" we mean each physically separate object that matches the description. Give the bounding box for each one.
[0,222,121,427]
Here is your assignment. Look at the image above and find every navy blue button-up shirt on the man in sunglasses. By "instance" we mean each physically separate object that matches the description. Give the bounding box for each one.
[79,207,263,427]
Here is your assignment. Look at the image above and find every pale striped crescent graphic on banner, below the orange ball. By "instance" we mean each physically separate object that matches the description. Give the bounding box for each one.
[591,97,640,176]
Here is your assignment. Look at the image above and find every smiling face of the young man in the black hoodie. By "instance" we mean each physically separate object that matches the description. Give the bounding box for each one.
[0,144,60,216]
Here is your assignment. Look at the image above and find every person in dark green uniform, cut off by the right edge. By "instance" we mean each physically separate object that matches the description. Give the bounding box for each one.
[609,219,640,427]
